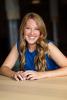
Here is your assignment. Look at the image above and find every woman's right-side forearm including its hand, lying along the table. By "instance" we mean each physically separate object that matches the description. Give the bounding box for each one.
[23,67,67,80]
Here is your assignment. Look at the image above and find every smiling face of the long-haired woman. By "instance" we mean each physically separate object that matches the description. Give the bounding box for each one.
[24,19,40,45]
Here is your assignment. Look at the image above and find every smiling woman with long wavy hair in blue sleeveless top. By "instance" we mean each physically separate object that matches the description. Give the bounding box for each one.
[0,12,67,81]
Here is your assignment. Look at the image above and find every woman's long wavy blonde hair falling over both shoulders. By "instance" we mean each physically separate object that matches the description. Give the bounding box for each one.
[19,12,48,71]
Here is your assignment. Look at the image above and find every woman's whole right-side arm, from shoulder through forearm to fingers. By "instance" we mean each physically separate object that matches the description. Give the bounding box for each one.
[24,42,67,80]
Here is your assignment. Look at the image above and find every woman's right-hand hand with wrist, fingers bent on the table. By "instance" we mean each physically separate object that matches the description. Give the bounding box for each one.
[23,70,44,80]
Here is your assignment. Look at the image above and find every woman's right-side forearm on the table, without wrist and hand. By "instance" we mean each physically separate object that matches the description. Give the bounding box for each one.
[44,67,67,77]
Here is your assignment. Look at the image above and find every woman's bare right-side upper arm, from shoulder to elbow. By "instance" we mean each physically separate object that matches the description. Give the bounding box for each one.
[48,42,67,67]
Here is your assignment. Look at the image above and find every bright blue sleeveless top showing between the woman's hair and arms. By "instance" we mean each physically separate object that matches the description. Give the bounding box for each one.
[24,49,58,70]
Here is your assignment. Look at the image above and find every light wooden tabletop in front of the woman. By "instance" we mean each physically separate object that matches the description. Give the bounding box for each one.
[0,75,67,100]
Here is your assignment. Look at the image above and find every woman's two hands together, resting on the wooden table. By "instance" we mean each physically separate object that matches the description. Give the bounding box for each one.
[13,70,44,81]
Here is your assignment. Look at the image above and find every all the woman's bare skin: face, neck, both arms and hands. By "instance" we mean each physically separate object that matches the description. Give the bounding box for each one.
[0,14,67,81]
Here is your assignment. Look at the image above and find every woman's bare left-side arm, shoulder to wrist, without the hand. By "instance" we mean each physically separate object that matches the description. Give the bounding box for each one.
[0,45,18,77]
